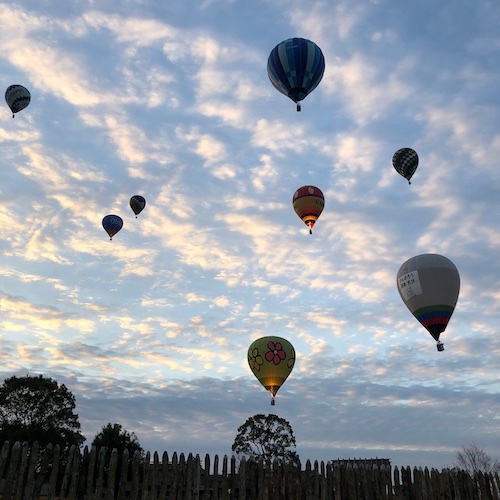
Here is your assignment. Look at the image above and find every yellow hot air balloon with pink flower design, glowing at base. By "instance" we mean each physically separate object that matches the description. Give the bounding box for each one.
[248,337,295,405]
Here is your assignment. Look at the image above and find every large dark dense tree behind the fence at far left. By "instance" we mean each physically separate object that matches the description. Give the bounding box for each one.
[0,375,85,453]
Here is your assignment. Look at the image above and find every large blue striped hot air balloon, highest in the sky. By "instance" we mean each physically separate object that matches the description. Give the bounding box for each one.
[267,38,325,111]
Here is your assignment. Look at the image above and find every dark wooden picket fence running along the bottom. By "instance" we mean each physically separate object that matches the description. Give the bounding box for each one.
[0,442,500,500]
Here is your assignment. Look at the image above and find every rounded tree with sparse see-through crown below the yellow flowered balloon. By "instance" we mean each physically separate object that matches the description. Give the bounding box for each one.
[231,414,299,466]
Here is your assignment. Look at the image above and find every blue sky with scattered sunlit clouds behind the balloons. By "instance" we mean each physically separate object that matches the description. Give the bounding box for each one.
[0,0,500,469]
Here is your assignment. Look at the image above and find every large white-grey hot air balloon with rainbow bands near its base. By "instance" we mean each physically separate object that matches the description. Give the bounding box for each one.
[396,253,460,351]
